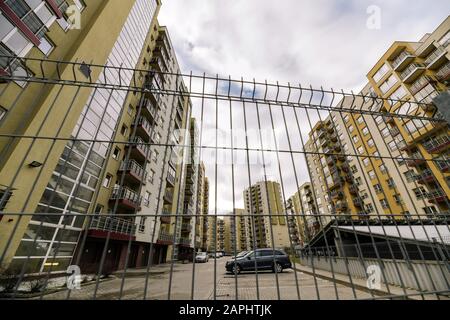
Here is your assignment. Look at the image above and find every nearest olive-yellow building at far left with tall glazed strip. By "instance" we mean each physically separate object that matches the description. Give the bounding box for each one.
[0,0,165,273]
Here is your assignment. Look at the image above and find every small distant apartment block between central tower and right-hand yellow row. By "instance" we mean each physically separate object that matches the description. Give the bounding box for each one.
[286,182,320,245]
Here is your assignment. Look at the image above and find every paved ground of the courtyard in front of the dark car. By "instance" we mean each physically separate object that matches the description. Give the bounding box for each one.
[38,258,370,300]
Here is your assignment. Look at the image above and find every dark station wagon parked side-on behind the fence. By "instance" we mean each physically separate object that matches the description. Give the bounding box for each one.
[225,249,292,274]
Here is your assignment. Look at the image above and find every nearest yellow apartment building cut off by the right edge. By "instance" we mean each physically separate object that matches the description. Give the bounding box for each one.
[367,16,450,217]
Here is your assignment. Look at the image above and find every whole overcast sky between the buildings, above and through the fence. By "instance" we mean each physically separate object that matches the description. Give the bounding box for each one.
[159,0,450,213]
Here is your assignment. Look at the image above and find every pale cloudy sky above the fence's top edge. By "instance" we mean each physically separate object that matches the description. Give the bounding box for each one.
[160,0,449,90]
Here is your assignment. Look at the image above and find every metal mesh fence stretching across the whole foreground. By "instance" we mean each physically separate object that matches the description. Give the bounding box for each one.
[0,57,450,300]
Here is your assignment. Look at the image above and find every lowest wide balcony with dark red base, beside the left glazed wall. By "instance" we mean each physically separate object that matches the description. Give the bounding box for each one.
[88,215,136,240]
